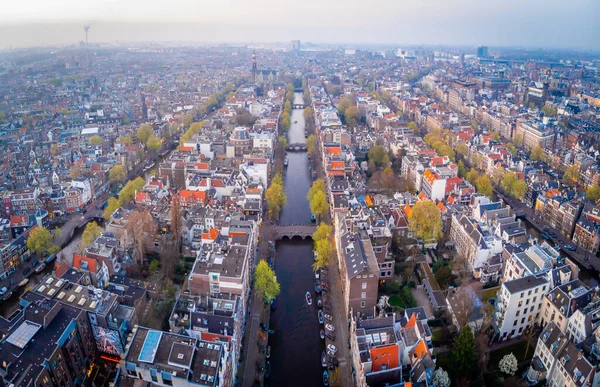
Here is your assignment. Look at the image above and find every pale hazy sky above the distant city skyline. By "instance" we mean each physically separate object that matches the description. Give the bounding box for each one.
[0,0,600,50]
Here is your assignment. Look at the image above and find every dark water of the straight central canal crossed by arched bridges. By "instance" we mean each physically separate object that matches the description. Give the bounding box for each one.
[266,93,324,386]
